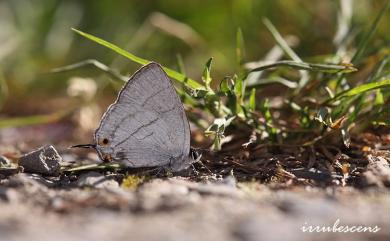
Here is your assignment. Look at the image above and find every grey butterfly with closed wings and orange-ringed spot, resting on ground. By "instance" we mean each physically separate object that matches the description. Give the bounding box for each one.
[74,62,194,172]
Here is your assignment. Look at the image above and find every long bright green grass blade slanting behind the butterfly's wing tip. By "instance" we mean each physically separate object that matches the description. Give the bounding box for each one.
[72,28,204,89]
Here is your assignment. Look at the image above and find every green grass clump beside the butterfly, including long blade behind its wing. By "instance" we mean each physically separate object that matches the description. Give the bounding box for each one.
[63,2,390,152]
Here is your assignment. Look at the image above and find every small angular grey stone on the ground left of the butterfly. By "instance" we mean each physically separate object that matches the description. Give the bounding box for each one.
[19,145,62,176]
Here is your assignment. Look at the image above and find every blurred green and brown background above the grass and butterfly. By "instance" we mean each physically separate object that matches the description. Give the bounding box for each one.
[0,0,390,116]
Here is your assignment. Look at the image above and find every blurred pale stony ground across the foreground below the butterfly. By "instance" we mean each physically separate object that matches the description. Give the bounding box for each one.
[0,173,390,241]
